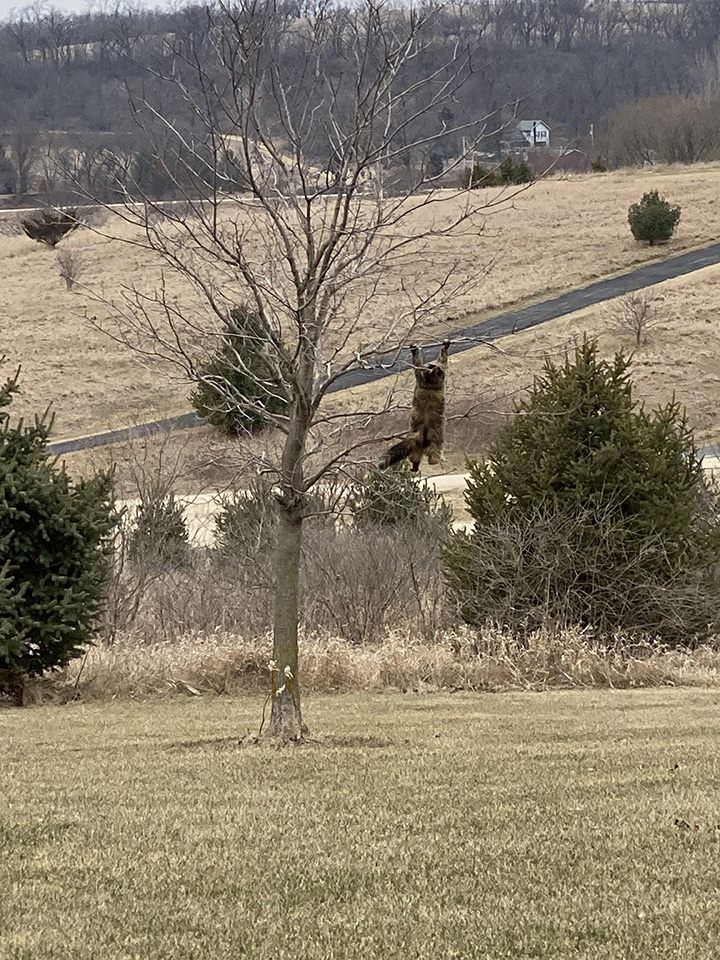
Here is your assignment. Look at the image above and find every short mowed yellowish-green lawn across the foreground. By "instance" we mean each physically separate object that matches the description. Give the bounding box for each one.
[0,689,720,960]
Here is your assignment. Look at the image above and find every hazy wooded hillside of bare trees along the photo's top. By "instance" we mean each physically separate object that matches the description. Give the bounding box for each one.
[0,0,720,197]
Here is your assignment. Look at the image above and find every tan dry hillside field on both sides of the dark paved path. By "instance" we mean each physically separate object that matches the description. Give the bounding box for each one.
[0,164,720,442]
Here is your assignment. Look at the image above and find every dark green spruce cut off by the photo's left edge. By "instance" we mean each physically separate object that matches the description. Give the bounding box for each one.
[0,368,117,703]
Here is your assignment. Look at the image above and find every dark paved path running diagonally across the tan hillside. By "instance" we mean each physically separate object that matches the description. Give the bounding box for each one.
[45,243,720,454]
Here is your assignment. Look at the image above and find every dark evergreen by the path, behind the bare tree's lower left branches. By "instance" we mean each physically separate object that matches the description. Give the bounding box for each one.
[190,307,287,434]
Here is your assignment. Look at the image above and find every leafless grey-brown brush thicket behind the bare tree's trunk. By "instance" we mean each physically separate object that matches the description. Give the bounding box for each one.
[105,510,453,644]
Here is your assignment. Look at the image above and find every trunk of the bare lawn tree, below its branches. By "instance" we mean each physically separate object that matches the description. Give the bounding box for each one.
[269,498,305,740]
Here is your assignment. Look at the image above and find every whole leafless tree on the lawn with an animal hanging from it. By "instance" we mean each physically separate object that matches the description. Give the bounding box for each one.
[86,0,523,739]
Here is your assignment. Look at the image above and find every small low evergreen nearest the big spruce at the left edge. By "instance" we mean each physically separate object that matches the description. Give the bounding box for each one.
[127,489,190,567]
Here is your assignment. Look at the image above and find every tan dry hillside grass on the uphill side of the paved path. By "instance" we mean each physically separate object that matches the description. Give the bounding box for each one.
[0,164,720,437]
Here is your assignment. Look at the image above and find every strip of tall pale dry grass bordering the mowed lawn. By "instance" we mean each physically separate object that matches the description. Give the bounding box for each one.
[29,628,720,702]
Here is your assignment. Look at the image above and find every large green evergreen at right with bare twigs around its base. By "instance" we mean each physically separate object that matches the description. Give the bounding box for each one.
[445,343,720,643]
